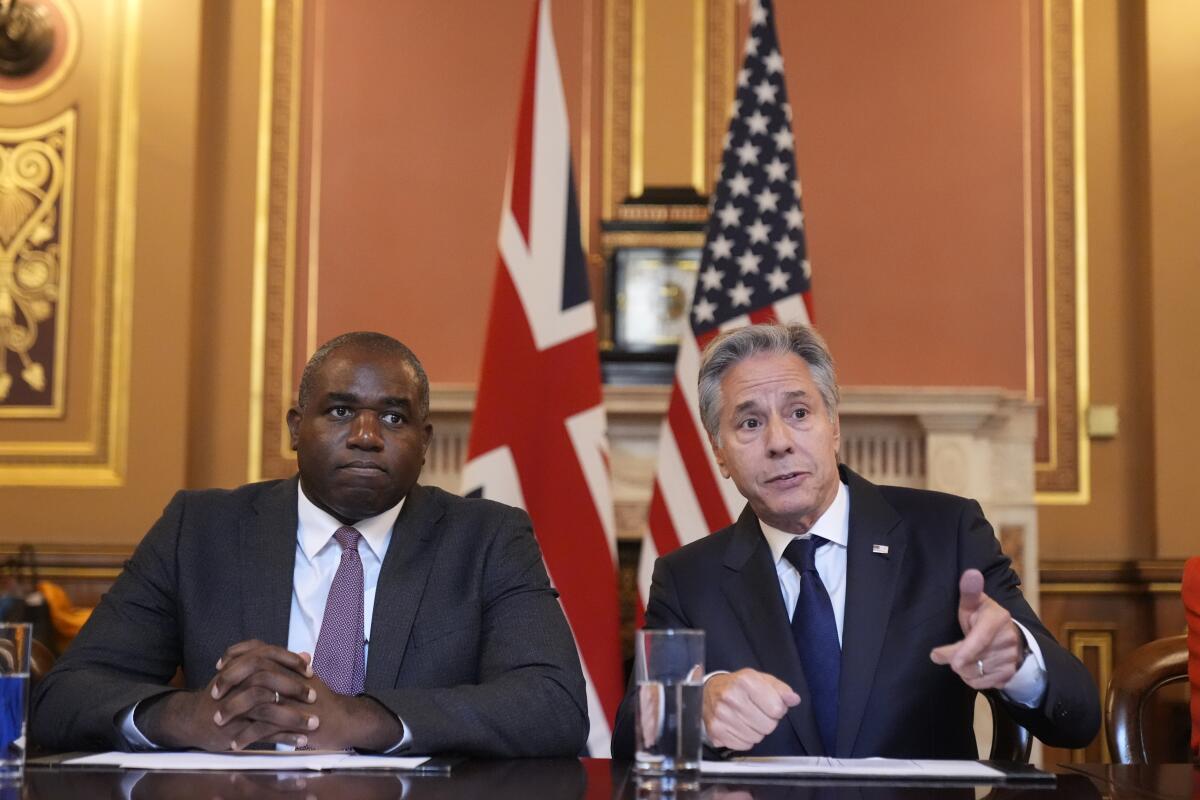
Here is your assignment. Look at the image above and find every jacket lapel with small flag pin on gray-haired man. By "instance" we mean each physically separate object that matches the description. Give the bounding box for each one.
[836,467,908,756]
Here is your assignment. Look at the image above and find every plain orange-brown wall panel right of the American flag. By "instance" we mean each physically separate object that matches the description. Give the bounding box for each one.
[779,0,1025,390]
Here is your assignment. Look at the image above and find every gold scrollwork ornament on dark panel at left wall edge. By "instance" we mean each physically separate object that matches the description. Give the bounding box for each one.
[0,112,74,405]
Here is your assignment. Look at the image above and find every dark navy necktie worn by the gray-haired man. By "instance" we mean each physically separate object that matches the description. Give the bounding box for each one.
[784,536,841,756]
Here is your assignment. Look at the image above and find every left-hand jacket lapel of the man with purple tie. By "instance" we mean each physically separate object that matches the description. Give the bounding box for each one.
[237,477,299,648]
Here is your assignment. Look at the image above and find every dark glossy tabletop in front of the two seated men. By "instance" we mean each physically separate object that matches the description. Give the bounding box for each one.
[11,758,1200,800]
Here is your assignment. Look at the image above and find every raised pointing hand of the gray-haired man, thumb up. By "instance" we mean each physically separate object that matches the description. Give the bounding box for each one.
[929,570,1025,691]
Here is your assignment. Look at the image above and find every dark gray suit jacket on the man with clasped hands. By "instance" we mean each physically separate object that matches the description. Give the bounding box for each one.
[31,477,588,757]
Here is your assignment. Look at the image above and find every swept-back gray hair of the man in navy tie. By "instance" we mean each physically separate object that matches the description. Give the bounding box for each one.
[698,323,839,439]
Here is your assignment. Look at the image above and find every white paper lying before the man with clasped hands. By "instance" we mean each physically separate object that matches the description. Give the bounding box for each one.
[62,751,430,771]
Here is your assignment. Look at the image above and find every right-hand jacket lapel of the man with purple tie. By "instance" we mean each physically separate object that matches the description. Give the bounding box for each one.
[366,486,445,690]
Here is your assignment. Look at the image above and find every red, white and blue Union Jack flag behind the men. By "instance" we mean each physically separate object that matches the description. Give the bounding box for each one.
[463,0,624,756]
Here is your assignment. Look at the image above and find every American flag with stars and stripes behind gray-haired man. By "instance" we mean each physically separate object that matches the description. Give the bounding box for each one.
[638,0,812,603]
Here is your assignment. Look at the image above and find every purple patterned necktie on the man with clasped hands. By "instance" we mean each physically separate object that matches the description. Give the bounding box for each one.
[312,527,366,694]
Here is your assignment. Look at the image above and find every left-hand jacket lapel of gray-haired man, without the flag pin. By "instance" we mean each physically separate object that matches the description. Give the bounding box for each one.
[722,506,824,756]
